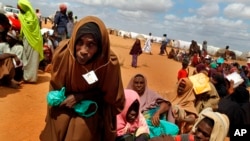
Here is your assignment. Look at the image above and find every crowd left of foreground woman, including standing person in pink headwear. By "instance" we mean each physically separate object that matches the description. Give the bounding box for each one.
[0,0,75,89]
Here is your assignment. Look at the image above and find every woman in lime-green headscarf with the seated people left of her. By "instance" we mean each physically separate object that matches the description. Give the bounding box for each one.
[0,0,44,88]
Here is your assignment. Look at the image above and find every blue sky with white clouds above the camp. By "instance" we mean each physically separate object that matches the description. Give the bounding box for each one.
[1,0,250,53]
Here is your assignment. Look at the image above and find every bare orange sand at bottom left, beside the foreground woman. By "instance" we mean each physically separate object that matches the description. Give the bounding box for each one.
[0,72,50,141]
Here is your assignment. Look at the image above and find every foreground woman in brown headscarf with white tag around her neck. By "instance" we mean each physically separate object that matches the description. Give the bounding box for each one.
[40,16,125,141]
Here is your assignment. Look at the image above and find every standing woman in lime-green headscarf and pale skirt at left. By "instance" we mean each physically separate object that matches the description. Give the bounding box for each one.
[17,0,44,83]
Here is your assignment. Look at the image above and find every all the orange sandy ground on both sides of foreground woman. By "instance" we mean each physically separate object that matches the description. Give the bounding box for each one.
[0,21,238,141]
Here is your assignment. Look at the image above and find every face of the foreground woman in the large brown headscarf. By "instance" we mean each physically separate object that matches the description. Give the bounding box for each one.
[76,34,98,65]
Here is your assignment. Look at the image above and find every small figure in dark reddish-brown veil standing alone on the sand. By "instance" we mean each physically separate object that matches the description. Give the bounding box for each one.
[129,38,142,68]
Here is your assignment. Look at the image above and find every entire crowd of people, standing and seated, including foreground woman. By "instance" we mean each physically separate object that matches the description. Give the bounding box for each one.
[0,0,250,141]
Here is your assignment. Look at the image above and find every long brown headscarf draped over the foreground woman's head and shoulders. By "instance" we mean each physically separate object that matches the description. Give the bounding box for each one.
[50,16,124,106]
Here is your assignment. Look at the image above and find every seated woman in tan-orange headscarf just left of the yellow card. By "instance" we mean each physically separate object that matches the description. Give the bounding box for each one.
[172,78,198,134]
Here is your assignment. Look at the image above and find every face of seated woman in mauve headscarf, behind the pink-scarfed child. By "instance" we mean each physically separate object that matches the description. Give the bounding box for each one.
[133,76,145,96]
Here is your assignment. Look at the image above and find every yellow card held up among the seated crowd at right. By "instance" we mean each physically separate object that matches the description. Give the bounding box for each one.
[189,73,211,95]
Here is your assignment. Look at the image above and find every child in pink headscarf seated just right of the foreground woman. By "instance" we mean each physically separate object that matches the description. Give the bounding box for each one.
[116,89,149,141]
